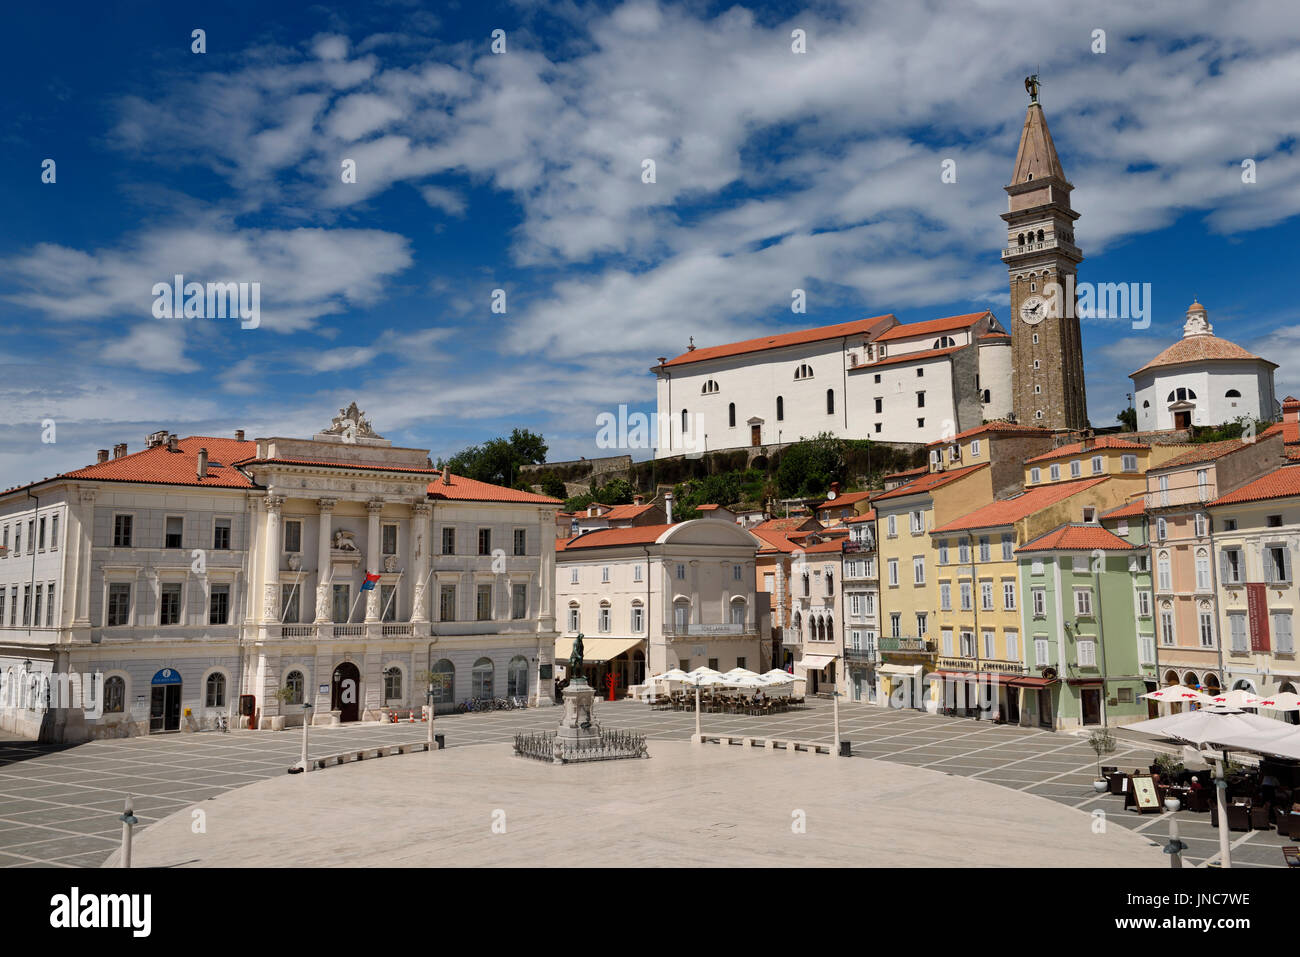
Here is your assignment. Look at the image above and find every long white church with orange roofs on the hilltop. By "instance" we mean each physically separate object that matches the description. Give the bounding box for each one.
[651,312,1013,458]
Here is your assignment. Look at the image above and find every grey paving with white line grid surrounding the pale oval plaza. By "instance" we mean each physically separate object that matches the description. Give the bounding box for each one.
[0,698,1288,867]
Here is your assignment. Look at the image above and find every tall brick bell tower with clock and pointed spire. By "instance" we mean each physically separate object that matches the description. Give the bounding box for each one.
[1002,74,1088,429]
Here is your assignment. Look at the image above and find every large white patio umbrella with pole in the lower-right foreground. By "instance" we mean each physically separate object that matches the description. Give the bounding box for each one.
[1123,696,1300,867]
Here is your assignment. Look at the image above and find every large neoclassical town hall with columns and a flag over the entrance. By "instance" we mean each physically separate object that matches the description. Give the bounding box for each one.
[0,404,559,741]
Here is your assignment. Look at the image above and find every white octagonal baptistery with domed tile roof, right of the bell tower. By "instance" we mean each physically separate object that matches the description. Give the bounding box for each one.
[1128,302,1282,432]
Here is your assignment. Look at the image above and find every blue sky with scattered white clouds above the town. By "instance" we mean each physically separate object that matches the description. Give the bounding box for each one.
[0,0,1300,486]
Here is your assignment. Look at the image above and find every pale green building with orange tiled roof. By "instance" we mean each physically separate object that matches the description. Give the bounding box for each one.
[1017,502,1156,731]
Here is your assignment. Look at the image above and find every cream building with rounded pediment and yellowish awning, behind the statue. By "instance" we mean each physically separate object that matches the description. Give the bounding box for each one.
[555,519,771,693]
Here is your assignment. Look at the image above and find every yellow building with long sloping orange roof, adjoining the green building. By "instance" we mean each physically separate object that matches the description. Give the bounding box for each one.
[930,473,1140,723]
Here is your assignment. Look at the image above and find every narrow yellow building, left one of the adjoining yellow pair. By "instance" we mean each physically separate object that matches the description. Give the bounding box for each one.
[872,462,993,710]
